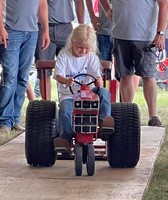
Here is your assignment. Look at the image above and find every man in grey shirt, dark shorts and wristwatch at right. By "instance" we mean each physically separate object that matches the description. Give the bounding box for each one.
[100,0,168,126]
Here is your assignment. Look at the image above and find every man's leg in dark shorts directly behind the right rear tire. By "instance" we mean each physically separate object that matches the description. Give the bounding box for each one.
[113,39,135,102]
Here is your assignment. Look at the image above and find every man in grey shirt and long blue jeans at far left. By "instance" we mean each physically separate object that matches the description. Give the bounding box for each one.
[0,0,50,132]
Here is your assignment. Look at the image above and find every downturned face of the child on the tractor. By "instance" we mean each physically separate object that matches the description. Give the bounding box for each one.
[72,42,91,57]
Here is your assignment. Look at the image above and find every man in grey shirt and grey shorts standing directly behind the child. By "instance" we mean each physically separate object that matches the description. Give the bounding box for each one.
[35,0,84,100]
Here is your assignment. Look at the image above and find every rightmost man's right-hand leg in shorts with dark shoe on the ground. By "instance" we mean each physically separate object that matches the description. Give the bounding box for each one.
[133,41,161,126]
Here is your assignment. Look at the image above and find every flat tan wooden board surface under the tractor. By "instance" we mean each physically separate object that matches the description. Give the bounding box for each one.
[0,127,165,200]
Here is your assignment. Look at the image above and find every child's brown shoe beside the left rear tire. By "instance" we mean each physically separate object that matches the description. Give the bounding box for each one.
[54,137,71,154]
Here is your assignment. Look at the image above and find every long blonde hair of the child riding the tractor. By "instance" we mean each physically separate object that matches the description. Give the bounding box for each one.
[65,24,98,53]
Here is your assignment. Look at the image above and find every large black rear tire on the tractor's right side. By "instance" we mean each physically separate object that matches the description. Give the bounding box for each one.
[107,103,141,168]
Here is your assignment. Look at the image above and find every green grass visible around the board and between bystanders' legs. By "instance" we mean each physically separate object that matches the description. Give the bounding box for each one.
[0,83,168,200]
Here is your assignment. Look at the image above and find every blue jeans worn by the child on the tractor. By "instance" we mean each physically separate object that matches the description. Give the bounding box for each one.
[59,88,111,143]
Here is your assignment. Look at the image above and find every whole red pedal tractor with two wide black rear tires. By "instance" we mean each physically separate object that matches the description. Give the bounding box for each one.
[25,61,141,176]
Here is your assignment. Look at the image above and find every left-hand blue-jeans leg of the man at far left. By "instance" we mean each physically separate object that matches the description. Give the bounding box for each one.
[0,41,20,129]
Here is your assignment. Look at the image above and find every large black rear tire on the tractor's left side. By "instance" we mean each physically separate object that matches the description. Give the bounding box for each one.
[25,100,56,166]
